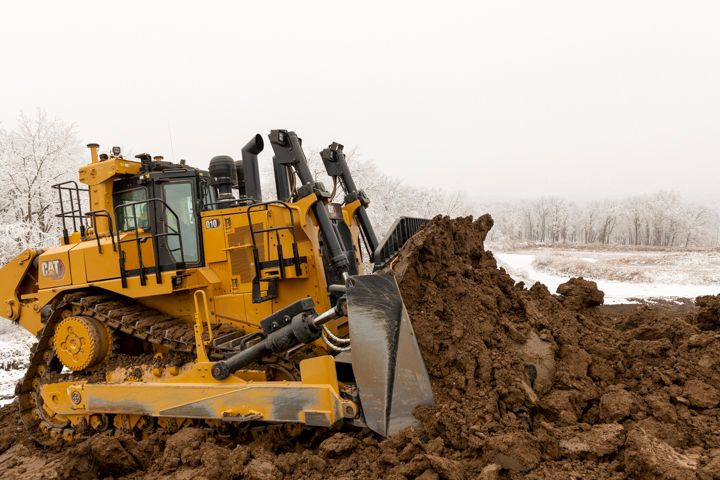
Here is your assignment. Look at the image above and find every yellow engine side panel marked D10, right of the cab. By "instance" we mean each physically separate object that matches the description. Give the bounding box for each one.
[194,195,330,330]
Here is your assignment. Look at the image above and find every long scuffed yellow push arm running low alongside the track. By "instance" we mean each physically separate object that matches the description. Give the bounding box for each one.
[40,363,357,427]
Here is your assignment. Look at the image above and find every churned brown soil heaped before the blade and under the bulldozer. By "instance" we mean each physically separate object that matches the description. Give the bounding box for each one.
[0,215,720,480]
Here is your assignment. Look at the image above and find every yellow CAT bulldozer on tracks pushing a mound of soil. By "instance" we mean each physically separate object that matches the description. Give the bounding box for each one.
[0,130,432,445]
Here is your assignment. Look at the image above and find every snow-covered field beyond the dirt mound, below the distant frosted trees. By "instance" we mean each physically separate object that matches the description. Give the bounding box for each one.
[494,248,720,304]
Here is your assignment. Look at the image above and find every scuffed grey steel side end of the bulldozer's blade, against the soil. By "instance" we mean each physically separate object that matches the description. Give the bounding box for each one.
[347,275,433,436]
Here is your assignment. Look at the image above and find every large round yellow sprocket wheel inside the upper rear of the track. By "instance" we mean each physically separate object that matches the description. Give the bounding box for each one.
[53,316,112,372]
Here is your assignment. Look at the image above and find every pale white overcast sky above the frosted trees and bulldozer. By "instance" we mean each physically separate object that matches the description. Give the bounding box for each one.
[0,0,720,199]
